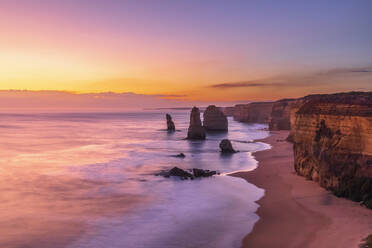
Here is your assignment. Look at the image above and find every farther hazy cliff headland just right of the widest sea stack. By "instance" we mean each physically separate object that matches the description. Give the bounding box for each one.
[234,102,274,123]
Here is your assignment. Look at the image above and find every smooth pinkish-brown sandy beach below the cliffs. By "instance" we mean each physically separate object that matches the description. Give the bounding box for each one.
[233,131,372,248]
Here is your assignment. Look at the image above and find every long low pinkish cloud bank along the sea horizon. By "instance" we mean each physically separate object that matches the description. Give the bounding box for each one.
[0,90,190,111]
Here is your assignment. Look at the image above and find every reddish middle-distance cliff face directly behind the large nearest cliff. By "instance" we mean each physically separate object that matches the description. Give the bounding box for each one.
[269,99,297,130]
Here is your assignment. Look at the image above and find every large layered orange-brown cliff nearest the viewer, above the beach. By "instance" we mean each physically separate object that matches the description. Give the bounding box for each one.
[292,92,372,208]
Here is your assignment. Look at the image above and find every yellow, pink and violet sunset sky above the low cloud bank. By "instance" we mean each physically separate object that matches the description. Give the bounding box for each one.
[0,0,372,108]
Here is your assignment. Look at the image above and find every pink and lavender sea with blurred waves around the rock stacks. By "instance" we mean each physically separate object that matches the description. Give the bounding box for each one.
[0,111,269,248]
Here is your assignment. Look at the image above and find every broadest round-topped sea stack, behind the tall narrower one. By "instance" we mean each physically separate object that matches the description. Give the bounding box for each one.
[203,105,228,131]
